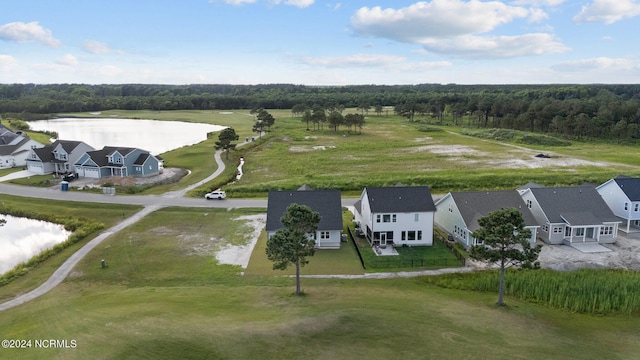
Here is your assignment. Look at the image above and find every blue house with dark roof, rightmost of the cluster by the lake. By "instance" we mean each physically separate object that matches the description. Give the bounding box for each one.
[74,146,163,179]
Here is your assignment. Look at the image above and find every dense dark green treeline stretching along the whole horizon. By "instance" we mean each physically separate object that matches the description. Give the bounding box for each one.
[0,84,640,139]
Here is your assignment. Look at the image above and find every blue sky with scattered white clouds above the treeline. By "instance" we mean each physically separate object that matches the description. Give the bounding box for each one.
[0,0,640,85]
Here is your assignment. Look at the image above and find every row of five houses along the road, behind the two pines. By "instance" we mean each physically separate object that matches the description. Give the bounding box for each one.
[267,175,640,248]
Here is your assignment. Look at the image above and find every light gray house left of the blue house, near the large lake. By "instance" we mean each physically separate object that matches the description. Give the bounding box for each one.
[27,140,95,175]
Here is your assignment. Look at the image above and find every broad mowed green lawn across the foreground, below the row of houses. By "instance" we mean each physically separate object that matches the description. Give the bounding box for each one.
[0,208,640,359]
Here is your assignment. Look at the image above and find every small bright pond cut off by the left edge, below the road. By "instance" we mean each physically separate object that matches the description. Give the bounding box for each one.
[0,215,71,274]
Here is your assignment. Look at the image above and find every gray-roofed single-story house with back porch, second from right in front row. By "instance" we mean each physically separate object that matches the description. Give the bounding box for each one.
[521,186,621,244]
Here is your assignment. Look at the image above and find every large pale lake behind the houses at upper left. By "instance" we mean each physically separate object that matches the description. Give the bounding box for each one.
[29,118,226,155]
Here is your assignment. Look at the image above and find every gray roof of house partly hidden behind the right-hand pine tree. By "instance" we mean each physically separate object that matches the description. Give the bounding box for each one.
[451,190,539,231]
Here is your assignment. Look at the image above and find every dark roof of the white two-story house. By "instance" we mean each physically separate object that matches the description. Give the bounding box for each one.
[365,186,436,213]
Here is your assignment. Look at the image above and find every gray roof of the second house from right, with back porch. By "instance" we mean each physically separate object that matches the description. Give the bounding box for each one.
[530,186,620,225]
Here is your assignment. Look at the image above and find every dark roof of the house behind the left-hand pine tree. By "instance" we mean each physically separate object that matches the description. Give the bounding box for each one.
[266,190,343,231]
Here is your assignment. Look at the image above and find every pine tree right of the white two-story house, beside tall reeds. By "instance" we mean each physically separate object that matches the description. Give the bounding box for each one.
[470,208,542,306]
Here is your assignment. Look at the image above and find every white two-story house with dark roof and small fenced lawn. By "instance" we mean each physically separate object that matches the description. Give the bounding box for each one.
[354,186,436,247]
